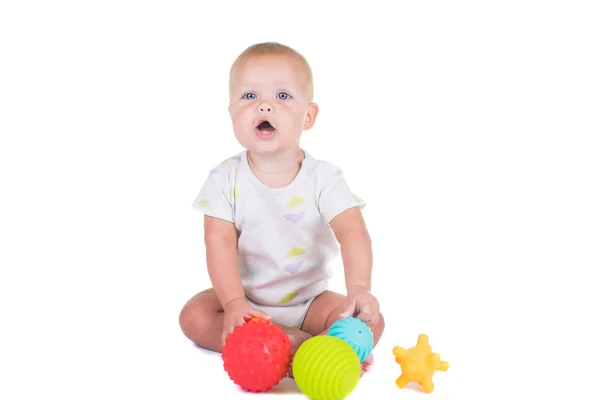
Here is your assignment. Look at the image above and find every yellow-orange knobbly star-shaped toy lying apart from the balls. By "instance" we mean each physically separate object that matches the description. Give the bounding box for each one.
[393,334,449,393]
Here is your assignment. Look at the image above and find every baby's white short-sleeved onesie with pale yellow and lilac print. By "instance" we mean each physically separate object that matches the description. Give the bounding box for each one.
[193,151,365,328]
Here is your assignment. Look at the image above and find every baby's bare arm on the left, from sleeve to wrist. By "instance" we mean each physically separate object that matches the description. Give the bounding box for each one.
[204,215,245,308]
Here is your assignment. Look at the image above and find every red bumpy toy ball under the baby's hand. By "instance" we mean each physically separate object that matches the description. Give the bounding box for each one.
[222,318,292,392]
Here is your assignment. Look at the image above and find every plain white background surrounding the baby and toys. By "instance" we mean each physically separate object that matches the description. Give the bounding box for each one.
[0,1,600,399]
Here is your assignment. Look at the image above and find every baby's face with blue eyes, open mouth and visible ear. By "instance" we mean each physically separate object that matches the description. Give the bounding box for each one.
[229,55,318,155]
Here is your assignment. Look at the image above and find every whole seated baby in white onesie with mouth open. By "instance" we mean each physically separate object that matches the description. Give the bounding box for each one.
[179,43,384,373]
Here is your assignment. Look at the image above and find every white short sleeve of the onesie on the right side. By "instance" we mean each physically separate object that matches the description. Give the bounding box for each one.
[317,167,366,223]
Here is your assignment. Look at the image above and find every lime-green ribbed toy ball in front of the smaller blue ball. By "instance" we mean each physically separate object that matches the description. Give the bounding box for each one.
[292,336,361,400]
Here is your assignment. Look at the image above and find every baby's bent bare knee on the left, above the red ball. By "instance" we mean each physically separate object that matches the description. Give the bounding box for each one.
[179,288,223,352]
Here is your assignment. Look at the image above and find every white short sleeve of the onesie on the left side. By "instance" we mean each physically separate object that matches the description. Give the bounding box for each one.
[192,170,233,222]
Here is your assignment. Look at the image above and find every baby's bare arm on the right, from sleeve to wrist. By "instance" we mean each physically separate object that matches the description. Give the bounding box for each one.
[331,207,373,291]
